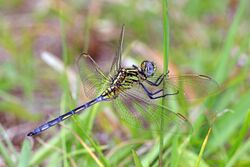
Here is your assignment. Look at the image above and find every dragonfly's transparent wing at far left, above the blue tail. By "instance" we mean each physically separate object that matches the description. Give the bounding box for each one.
[76,53,110,98]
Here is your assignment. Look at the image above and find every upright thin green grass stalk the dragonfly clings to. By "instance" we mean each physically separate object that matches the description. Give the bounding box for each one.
[159,0,169,166]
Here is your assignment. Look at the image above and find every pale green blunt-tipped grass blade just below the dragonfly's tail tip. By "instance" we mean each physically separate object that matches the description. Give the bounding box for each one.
[18,139,32,167]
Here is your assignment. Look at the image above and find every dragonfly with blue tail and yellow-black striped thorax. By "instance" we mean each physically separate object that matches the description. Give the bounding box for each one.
[27,25,218,136]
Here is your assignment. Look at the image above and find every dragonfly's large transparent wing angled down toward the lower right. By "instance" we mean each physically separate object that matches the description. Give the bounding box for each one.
[114,88,192,133]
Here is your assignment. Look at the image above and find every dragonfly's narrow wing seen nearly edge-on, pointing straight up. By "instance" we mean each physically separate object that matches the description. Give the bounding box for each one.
[109,25,125,77]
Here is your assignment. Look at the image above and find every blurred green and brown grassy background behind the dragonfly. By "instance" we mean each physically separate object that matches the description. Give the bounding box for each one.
[0,0,250,167]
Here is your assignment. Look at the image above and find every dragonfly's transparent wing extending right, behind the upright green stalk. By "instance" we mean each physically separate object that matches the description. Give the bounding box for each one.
[145,74,219,100]
